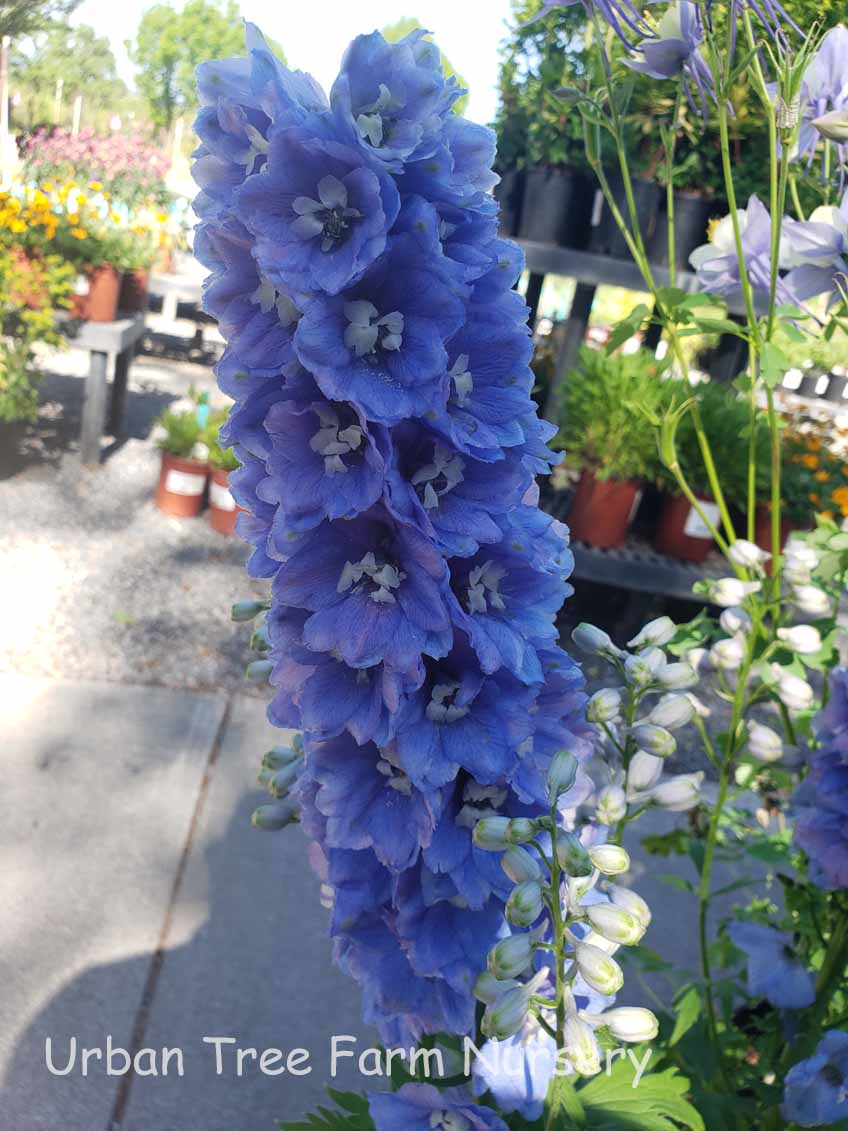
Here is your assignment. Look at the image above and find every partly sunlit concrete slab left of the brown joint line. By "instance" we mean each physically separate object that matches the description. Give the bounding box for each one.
[0,675,226,1131]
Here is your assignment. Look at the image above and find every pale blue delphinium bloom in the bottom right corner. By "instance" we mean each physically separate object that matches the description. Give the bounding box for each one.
[782,1029,848,1128]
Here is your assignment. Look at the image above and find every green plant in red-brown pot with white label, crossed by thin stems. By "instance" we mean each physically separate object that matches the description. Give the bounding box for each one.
[654,381,755,562]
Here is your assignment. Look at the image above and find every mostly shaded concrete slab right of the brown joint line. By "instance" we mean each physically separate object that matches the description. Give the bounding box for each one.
[120,697,374,1131]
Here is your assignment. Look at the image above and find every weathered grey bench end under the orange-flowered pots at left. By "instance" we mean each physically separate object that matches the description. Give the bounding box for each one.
[58,314,145,466]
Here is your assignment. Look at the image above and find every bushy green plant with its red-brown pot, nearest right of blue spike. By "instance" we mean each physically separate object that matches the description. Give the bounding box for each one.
[559,346,664,549]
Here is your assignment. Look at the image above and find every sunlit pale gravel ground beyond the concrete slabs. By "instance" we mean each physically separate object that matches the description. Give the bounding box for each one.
[0,355,267,694]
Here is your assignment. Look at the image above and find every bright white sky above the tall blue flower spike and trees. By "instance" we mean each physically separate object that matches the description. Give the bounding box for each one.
[75,0,510,122]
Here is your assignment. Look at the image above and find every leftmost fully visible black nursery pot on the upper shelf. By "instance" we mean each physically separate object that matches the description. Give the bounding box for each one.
[518,169,595,249]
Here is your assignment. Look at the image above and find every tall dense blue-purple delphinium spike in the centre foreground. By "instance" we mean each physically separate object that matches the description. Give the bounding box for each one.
[196,25,591,1049]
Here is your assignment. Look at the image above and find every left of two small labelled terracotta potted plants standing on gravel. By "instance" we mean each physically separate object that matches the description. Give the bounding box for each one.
[156,395,209,518]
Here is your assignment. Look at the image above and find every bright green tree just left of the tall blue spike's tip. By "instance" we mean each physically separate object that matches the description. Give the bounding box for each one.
[127,0,284,129]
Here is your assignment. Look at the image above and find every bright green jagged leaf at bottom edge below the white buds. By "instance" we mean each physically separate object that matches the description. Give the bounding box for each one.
[578,1052,704,1131]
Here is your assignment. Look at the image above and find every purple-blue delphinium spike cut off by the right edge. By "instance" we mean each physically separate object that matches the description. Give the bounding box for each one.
[793,667,848,891]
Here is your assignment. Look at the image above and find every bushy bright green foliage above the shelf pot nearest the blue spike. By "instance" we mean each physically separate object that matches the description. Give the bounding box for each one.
[557,346,664,480]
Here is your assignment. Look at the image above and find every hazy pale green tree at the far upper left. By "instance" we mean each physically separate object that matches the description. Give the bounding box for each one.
[11,24,130,130]
